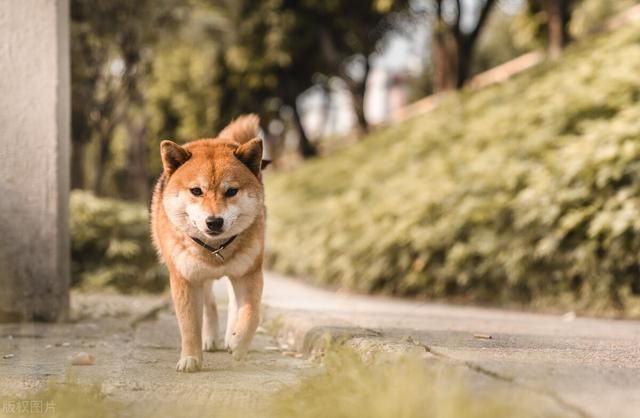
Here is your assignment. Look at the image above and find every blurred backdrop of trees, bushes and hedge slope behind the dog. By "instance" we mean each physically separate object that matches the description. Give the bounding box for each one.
[70,0,640,317]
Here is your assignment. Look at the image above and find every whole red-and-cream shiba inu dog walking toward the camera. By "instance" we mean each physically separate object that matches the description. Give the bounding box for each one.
[151,114,265,372]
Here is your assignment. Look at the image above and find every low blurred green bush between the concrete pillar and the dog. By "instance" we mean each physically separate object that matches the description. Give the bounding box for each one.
[71,191,169,292]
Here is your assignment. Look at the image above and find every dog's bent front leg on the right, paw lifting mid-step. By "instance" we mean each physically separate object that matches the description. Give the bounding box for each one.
[228,264,263,360]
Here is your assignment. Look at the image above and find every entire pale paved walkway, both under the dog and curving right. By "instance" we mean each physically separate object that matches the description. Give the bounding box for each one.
[0,273,640,418]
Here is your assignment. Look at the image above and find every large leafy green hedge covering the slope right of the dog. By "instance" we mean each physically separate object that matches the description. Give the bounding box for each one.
[267,27,640,317]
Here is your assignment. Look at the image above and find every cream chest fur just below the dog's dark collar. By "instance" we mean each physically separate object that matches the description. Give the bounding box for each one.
[172,240,260,282]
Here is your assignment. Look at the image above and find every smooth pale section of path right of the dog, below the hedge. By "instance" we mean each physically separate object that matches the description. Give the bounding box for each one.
[264,274,640,418]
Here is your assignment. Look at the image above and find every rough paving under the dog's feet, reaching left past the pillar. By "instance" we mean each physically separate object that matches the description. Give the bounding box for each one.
[0,294,314,418]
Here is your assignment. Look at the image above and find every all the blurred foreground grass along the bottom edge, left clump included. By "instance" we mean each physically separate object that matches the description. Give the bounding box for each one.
[0,347,556,418]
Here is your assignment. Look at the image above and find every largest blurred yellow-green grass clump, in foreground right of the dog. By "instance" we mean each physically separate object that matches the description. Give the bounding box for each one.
[272,348,552,418]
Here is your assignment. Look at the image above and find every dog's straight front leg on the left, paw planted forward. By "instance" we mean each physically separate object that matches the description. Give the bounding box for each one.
[171,274,202,372]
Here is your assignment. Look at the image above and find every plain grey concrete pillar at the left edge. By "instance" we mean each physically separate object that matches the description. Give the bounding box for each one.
[0,0,70,322]
